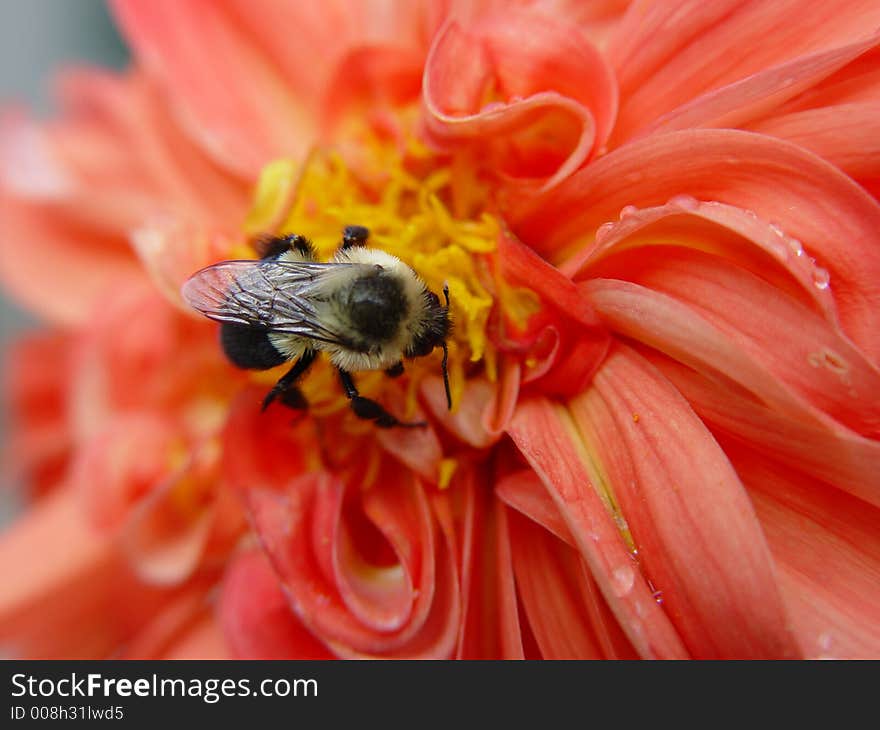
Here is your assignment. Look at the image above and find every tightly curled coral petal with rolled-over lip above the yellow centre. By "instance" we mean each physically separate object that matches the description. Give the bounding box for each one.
[424,10,617,188]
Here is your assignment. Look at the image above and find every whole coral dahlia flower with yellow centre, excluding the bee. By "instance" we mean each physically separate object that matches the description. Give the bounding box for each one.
[0,0,880,658]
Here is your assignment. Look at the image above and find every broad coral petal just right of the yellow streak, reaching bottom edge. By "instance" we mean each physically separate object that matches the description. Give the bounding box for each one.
[569,349,799,658]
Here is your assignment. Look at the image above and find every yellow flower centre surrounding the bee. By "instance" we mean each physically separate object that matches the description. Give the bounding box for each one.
[236,127,538,414]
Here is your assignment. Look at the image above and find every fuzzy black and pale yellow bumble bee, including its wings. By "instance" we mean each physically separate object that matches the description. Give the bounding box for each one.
[182,226,452,428]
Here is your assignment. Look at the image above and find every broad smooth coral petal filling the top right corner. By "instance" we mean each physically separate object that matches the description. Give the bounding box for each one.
[609,0,880,144]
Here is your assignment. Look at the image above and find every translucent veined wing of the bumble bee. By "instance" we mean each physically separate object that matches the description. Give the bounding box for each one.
[181,261,343,343]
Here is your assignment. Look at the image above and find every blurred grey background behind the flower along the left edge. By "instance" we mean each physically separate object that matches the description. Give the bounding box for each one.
[0,0,128,527]
